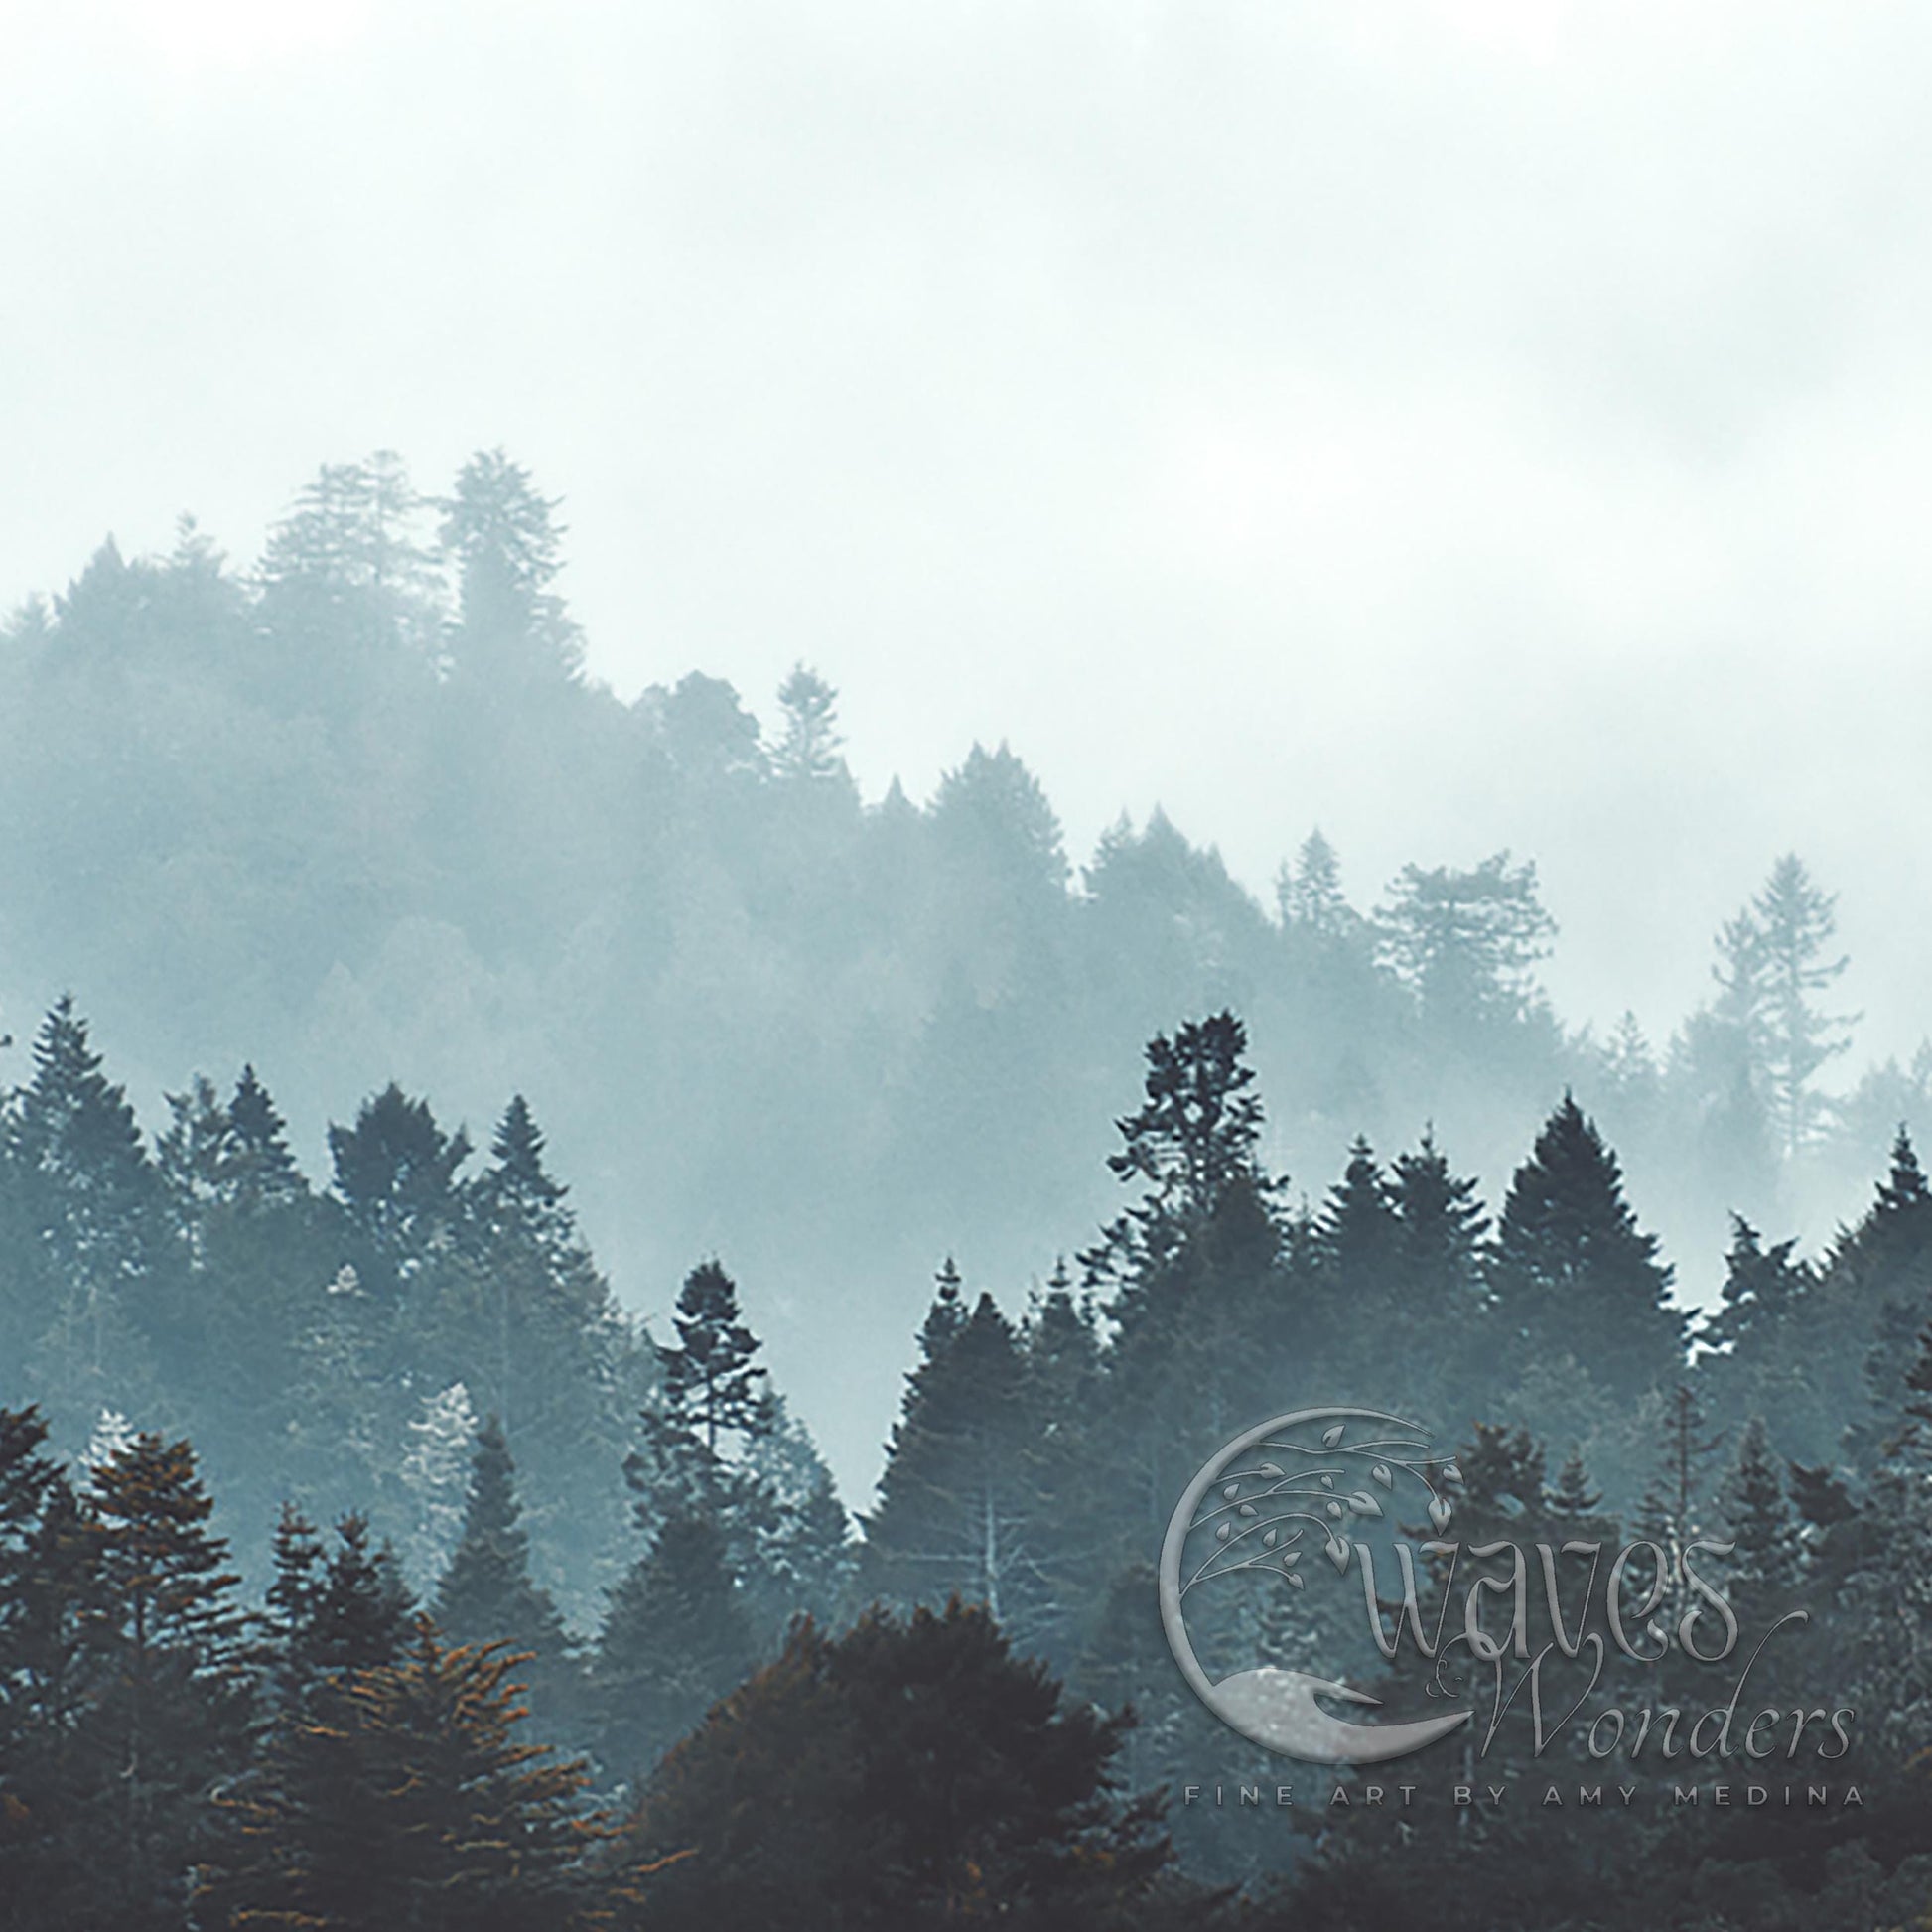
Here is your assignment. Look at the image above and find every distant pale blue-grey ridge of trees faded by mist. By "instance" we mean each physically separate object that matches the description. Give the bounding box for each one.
[0,452,1932,1489]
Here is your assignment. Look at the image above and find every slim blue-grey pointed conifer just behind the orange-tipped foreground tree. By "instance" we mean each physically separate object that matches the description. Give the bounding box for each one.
[431,1416,576,1724]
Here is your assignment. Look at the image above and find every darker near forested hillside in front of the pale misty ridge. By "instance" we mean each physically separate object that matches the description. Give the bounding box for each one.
[0,1001,1932,1932]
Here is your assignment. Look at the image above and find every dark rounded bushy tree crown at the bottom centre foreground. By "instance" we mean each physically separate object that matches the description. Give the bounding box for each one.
[626,1601,1167,1932]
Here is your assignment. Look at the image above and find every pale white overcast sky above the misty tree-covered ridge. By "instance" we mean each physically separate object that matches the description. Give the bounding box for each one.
[0,0,1932,1058]
